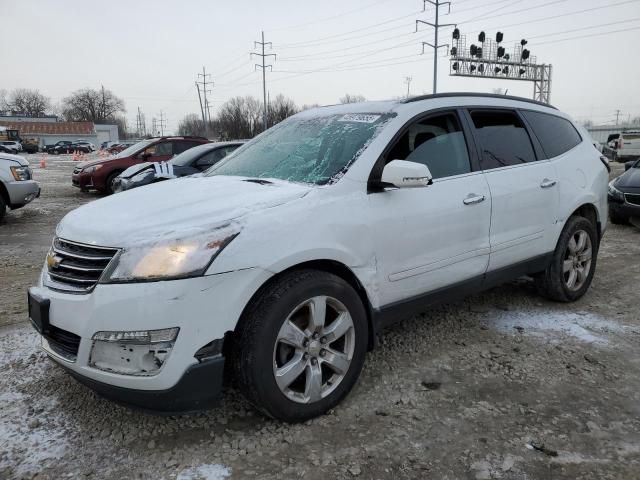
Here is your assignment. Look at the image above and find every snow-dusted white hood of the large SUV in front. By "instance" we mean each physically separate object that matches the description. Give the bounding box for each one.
[56,176,313,247]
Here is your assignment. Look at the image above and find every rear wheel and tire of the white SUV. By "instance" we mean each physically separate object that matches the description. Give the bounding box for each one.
[534,216,599,302]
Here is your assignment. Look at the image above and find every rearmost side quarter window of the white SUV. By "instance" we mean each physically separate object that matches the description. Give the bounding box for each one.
[522,110,582,158]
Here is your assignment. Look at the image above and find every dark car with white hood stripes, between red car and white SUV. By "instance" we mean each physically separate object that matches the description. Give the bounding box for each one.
[114,141,244,192]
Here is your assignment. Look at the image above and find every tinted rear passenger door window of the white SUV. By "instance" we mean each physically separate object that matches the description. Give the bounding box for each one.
[471,110,537,170]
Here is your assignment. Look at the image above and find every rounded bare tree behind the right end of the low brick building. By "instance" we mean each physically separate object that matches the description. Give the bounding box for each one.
[62,87,126,123]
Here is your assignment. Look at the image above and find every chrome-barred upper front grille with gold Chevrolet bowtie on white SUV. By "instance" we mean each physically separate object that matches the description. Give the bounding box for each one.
[47,238,118,293]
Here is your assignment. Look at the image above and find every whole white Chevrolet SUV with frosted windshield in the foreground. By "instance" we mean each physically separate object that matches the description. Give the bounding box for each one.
[29,94,608,421]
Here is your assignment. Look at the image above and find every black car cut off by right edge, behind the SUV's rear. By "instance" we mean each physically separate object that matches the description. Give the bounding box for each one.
[609,160,640,224]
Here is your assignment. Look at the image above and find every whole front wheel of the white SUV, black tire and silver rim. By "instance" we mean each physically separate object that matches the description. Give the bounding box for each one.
[233,270,368,422]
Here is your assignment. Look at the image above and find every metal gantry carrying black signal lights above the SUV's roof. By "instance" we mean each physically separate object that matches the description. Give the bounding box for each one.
[449,29,552,103]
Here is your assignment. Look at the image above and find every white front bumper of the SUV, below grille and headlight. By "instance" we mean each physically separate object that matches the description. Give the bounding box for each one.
[32,268,270,410]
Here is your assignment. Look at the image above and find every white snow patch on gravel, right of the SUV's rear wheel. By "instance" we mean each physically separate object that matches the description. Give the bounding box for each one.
[492,310,628,345]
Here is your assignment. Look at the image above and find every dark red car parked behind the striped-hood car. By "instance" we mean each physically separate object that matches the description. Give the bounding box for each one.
[71,136,209,194]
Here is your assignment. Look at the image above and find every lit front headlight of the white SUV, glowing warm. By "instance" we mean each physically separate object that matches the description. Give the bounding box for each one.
[103,224,240,283]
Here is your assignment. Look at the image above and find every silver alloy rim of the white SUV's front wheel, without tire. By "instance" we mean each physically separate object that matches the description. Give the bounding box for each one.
[273,296,355,404]
